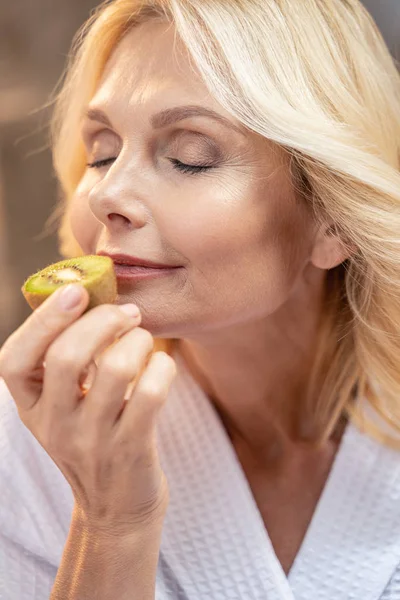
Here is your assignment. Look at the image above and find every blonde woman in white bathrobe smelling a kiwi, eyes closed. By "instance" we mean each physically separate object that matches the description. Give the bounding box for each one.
[0,0,400,600]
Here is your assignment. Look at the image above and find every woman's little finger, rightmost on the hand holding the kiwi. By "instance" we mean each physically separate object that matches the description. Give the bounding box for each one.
[118,351,177,438]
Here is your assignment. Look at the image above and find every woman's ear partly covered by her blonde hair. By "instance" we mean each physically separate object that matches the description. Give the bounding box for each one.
[310,223,356,270]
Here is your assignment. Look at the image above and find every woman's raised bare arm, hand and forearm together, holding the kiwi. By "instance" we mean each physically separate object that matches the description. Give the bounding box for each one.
[0,285,176,600]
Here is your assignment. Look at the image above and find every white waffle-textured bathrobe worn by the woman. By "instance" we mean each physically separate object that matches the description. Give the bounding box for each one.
[0,353,400,600]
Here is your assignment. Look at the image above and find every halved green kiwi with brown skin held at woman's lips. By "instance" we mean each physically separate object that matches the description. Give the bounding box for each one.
[21,255,117,312]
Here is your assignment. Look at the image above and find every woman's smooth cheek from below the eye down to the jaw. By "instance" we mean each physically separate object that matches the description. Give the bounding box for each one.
[170,185,312,324]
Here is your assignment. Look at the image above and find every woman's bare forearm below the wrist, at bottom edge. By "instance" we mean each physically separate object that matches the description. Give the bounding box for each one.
[49,506,162,600]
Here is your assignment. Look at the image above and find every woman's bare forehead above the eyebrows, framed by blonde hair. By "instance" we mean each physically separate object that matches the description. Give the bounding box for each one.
[93,21,214,112]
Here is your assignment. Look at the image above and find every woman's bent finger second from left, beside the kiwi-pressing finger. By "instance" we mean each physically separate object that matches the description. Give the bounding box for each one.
[41,304,141,414]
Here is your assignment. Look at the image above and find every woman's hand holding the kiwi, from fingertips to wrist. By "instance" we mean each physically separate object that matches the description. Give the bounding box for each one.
[0,285,176,535]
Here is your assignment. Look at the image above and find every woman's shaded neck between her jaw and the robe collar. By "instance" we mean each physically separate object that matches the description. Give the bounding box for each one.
[178,266,341,460]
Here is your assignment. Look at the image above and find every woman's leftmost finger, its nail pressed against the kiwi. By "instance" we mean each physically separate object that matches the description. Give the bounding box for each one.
[0,284,89,408]
